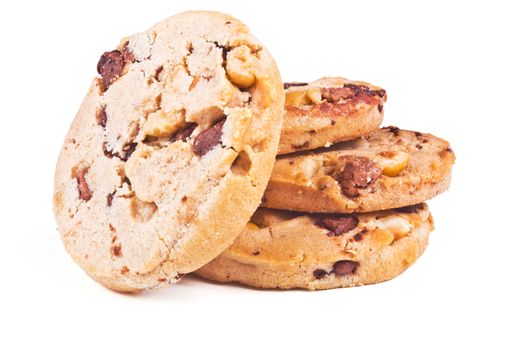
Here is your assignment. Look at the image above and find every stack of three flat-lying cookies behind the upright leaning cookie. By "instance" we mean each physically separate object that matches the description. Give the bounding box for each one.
[197,78,455,290]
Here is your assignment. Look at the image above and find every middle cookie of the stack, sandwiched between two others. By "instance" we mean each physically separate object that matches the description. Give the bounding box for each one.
[262,127,455,213]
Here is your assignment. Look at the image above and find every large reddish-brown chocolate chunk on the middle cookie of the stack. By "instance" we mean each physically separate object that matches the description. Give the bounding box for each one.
[335,156,382,198]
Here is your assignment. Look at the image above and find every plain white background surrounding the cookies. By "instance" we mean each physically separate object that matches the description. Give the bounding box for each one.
[0,0,524,349]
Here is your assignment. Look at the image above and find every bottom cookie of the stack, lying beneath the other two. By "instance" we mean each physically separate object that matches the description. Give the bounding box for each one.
[196,204,433,290]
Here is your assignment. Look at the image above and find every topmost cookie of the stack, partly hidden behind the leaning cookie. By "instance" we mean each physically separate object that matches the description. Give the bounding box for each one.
[278,78,387,154]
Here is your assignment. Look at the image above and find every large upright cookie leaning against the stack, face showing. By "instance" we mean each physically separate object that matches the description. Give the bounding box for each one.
[53,12,284,291]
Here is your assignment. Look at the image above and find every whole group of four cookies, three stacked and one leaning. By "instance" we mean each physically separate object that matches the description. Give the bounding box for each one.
[53,11,454,292]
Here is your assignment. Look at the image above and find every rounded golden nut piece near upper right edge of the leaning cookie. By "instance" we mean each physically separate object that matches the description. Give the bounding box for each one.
[226,46,256,89]
